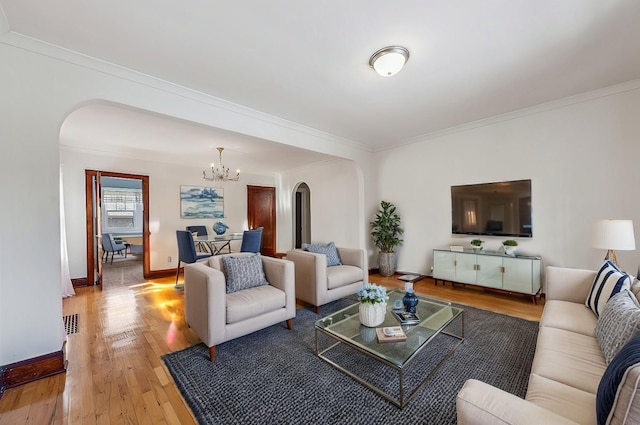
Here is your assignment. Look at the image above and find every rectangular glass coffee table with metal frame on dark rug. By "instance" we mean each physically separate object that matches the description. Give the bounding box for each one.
[315,291,464,408]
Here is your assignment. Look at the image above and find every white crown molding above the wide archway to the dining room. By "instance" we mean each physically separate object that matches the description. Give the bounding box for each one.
[0,31,373,153]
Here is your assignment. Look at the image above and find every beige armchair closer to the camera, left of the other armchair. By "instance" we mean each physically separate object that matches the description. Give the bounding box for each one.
[184,253,296,361]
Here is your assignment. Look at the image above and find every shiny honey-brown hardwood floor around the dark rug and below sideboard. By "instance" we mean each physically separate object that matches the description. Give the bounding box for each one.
[0,275,542,425]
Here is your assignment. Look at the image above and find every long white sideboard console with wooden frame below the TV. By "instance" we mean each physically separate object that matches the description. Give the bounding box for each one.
[433,249,542,303]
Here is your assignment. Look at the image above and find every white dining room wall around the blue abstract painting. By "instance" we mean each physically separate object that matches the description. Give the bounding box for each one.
[60,147,275,278]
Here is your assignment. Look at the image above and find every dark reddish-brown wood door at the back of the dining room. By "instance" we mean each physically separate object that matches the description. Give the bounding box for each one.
[247,186,276,257]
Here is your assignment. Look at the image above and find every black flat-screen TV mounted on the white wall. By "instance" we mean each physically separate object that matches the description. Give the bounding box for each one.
[451,180,533,238]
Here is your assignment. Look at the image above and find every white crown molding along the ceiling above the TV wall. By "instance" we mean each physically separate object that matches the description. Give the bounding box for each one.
[376,79,640,153]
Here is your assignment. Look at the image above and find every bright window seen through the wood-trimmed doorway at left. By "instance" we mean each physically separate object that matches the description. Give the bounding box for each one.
[102,187,142,230]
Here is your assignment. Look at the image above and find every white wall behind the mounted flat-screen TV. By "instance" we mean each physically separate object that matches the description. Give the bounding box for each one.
[377,83,640,273]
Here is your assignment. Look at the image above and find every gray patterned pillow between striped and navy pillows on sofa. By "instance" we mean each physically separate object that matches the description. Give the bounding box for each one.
[596,290,640,364]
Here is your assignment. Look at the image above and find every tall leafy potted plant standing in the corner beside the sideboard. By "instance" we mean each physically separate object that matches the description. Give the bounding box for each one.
[371,201,404,276]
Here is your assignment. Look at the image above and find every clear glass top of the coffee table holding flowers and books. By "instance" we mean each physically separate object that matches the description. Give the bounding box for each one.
[315,291,462,368]
